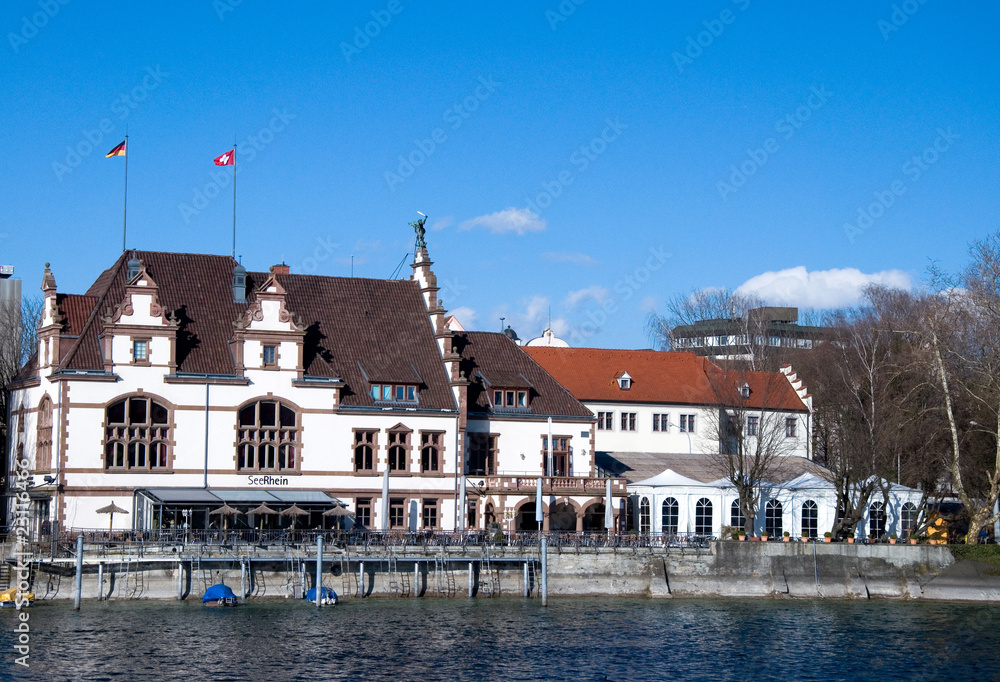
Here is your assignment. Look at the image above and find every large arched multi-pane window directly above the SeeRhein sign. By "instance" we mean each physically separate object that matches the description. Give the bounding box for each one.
[236,400,299,471]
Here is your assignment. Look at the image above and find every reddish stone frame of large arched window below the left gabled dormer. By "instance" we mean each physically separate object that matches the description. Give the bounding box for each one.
[101,391,175,473]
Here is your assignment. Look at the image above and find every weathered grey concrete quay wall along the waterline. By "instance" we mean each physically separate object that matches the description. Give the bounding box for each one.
[21,541,1000,601]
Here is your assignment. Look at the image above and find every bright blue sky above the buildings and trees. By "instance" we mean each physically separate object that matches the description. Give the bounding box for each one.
[0,0,1000,348]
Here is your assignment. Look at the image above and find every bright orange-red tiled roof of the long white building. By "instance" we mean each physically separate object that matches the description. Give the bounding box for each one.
[524,346,806,412]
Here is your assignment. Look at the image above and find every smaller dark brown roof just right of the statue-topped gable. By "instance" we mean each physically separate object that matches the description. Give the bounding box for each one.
[454,332,593,420]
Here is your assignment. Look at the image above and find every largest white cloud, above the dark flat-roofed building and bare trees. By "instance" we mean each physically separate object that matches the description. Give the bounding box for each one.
[737,265,912,309]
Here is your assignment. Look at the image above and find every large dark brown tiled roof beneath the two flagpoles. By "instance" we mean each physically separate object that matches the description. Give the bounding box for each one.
[48,251,456,409]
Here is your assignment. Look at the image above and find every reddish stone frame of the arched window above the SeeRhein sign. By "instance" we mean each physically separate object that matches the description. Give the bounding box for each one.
[234,394,302,473]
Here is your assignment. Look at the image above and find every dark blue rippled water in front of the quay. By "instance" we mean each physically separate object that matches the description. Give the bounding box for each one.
[0,598,1000,682]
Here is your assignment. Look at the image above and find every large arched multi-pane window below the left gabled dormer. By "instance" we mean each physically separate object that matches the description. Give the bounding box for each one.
[104,395,170,470]
